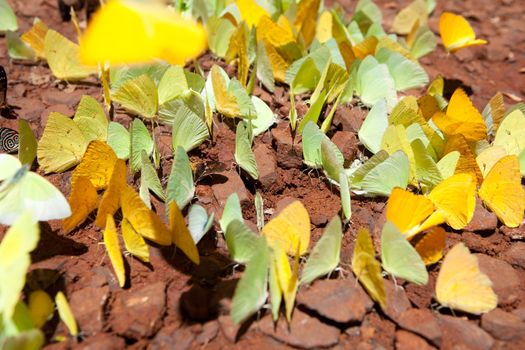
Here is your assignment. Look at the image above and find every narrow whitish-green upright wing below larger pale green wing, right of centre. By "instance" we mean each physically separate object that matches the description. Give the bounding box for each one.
[358,100,388,154]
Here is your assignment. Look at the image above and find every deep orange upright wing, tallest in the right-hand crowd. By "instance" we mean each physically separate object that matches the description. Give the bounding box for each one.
[432,88,487,141]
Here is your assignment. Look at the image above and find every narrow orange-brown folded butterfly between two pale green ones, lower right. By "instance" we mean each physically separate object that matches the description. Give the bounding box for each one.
[352,228,386,309]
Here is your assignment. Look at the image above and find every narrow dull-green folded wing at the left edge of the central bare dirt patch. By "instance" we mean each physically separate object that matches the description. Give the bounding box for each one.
[166,146,195,210]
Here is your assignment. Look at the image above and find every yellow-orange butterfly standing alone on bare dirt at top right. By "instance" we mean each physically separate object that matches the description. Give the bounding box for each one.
[439,12,487,53]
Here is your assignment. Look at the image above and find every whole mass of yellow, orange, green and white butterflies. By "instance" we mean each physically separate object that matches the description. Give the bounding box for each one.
[0,0,525,333]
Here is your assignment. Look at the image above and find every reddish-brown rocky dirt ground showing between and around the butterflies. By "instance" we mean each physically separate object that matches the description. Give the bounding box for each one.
[0,0,525,349]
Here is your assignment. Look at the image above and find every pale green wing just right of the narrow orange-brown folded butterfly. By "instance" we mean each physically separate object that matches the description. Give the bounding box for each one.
[381,221,428,285]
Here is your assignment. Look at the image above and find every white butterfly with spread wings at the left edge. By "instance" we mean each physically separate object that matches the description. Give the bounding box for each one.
[0,154,71,225]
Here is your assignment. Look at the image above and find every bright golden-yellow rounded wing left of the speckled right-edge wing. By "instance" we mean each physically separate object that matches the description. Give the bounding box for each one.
[420,174,476,230]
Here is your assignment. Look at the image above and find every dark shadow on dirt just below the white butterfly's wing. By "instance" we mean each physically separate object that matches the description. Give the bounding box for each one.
[31,222,88,264]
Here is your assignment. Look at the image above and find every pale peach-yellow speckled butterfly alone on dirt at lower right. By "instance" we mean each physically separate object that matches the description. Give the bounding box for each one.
[436,243,498,314]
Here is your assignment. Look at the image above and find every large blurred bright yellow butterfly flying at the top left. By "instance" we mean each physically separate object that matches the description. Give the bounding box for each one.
[80,0,207,66]
